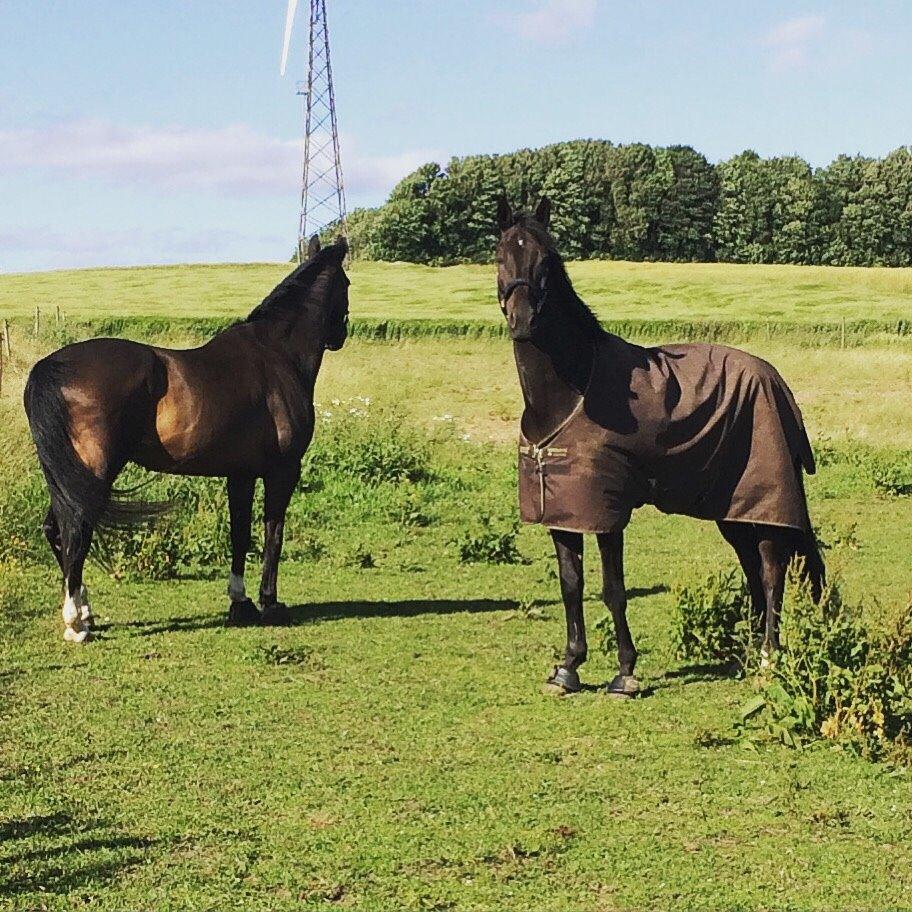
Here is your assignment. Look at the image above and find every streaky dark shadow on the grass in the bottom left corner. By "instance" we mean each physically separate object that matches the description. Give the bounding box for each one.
[0,812,159,897]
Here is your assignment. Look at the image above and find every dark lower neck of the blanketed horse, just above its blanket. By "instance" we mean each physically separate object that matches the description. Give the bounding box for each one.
[513,318,595,441]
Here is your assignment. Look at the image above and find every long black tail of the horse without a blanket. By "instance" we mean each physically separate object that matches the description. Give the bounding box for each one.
[24,358,169,534]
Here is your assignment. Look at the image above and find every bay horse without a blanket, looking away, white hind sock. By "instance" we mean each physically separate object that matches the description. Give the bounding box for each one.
[24,237,349,643]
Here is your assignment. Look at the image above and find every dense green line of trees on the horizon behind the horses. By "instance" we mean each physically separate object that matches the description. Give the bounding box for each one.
[340,140,912,266]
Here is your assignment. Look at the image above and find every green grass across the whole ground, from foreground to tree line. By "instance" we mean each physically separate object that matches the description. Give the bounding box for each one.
[0,264,912,912]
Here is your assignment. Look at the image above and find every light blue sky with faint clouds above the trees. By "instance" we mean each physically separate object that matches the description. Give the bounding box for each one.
[0,0,912,272]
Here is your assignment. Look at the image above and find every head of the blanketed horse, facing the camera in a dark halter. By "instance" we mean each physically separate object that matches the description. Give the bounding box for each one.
[497,197,556,342]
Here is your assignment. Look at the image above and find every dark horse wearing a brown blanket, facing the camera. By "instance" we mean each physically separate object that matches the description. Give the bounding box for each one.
[497,200,824,696]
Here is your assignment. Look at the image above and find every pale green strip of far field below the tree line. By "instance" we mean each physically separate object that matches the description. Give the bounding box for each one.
[0,260,912,324]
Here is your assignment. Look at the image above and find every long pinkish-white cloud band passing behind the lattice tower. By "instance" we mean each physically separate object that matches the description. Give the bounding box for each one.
[0,120,446,196]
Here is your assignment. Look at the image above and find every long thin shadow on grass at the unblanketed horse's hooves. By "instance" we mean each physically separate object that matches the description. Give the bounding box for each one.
[117,599,519,637]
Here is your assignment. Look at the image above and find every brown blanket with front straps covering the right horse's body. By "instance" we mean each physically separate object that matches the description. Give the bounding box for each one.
[519,334,814,532]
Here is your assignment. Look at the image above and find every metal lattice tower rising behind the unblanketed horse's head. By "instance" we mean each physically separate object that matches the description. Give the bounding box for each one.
[298,0,346,262]
